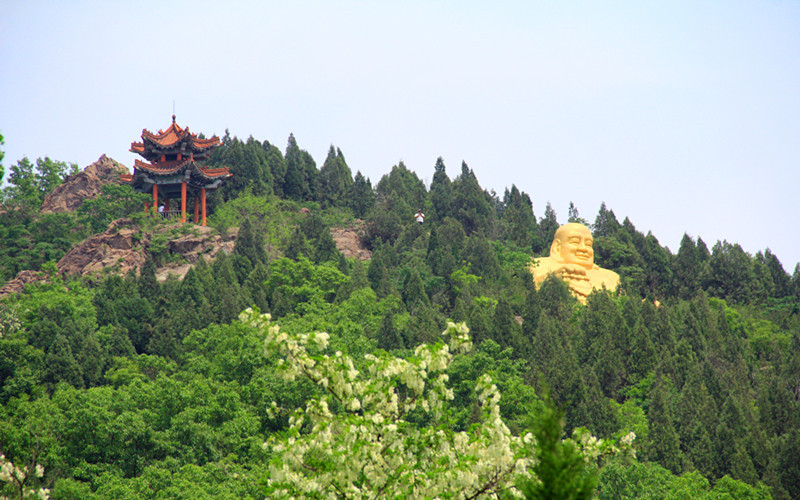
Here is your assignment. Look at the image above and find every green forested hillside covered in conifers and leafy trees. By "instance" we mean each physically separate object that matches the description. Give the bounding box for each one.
[0,135,800,499]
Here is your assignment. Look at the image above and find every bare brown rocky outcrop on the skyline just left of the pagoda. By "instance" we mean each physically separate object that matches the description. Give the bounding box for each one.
[42,155,130,214]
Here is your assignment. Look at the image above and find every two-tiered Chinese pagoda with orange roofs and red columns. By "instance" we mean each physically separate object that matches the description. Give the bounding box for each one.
[122,115,233,226]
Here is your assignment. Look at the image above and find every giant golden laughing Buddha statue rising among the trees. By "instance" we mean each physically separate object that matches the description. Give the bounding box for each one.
[528,222,619,304]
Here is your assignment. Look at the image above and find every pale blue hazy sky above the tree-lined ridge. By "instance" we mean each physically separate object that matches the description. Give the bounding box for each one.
[0,0,800,273]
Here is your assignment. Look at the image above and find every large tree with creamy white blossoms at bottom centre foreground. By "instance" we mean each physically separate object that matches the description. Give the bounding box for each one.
[247,310,533,499]
